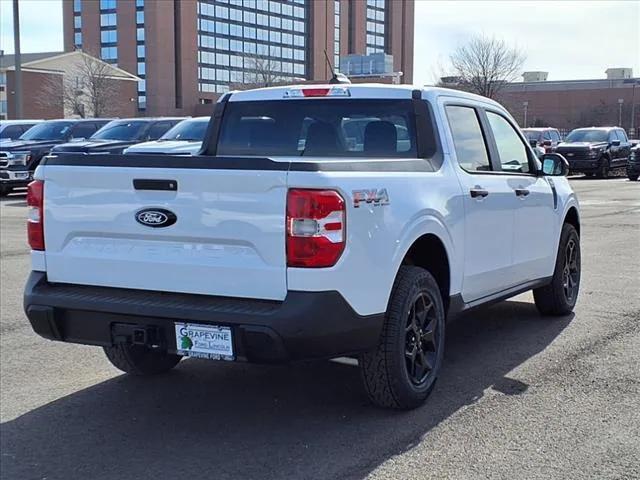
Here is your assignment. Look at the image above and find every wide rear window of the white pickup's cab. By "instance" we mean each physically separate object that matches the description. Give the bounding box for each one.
[217,99,424,158]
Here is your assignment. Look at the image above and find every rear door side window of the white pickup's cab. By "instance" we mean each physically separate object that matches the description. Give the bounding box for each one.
[446,105,491,173]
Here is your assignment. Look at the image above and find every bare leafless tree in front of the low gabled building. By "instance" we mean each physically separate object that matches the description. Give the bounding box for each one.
[38,55,124,118]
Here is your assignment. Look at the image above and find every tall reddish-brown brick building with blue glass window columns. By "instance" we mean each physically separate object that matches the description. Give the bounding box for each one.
[63,0,414,115]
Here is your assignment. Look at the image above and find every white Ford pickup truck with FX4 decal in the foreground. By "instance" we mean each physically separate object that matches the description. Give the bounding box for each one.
[24,85,580,409]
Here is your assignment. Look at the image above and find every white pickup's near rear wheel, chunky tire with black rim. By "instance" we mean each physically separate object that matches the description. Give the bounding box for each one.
[360,266,445,410]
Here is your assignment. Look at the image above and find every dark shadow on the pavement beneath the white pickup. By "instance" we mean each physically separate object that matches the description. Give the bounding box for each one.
[1,301,572,480]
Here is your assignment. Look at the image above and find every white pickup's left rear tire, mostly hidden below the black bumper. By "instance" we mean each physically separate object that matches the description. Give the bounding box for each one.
[104,344,182,376]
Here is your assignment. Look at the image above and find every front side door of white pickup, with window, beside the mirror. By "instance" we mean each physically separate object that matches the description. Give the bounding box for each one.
[484,109,559,285]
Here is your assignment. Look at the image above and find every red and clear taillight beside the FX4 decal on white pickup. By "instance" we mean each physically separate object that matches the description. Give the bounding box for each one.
[287,189,346,268]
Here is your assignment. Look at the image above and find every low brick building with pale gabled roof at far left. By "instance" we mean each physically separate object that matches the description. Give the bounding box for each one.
[0,52,139,120]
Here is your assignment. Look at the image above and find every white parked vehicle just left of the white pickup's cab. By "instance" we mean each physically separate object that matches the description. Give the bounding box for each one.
[124,117,209,155]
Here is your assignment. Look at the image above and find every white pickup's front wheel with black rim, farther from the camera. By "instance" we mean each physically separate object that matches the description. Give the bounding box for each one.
[533,223,581,316]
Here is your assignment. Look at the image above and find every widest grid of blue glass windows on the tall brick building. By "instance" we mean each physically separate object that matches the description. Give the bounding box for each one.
[197,0,308,93]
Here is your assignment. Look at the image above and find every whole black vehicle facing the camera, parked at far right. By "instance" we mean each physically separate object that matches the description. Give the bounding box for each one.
[556,127,631,178]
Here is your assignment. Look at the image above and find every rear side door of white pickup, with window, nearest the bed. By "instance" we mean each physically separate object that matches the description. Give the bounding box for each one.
[444,104,516,303]
